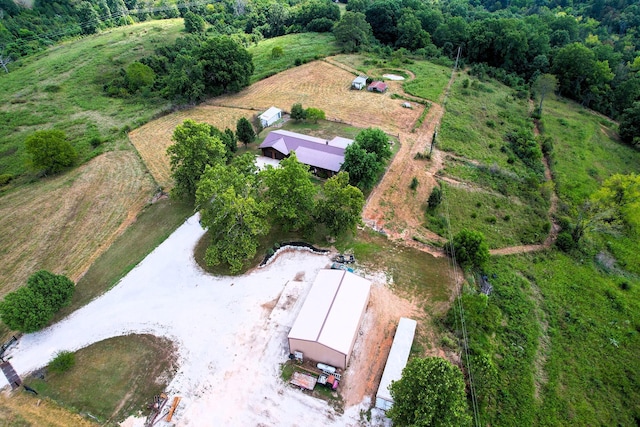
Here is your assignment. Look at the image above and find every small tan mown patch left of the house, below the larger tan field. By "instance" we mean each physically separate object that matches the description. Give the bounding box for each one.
[129,104,258,189]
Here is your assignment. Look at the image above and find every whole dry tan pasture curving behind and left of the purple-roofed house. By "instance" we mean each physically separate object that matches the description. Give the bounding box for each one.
[129,61,423,188]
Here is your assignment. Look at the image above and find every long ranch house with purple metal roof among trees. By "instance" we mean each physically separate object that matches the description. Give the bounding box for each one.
[260,130,353,176]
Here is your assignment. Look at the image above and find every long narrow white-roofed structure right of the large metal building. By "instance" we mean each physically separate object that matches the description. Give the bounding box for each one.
[376,317,417,411]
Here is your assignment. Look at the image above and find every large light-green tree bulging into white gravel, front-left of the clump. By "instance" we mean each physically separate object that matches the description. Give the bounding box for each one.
[196,160,269,273]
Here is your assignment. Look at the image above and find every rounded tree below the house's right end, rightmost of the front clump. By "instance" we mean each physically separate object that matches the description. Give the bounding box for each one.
[316,172,364,236]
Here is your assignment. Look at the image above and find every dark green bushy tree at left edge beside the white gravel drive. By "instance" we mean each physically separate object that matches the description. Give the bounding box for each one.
[0,270,75,333]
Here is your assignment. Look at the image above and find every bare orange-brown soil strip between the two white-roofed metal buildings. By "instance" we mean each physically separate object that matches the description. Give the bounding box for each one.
[341,283,419,408]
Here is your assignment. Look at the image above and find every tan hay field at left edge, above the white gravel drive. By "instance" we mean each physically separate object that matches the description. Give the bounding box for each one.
[0,151,155,295]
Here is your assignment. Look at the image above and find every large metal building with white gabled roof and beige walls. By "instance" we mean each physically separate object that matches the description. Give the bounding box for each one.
[289,270,371,369]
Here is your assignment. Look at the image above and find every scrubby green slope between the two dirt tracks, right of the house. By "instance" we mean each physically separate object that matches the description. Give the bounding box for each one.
[427,73,550,248]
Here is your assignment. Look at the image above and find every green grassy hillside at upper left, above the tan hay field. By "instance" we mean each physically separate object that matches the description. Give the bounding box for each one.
[0,19,184,180]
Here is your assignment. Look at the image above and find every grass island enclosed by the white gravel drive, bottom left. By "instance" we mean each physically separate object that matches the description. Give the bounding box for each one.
[29,335,177,426]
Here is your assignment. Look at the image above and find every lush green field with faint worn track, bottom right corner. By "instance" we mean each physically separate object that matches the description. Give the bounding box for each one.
[465,252,640,426]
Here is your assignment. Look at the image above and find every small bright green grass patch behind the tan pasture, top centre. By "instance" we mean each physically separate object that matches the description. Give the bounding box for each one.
[248,33,338,83]
